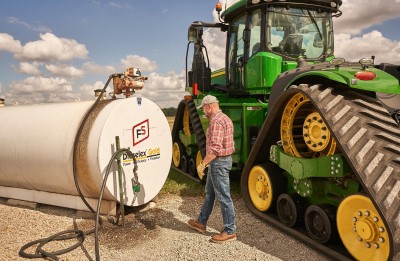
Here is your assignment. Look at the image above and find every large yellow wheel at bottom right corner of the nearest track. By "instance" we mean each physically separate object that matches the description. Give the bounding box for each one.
[336,195,390,261]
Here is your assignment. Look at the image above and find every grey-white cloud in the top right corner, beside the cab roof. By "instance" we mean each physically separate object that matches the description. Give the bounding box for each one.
[334,0,400,34]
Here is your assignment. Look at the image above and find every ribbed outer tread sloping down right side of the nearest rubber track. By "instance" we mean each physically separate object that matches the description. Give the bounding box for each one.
[299,85,400,260]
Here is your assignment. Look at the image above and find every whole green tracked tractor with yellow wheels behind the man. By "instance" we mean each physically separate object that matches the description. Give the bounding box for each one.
[172,0,400,260]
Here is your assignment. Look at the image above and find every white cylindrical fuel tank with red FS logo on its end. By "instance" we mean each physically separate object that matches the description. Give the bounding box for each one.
[0,97,172,212]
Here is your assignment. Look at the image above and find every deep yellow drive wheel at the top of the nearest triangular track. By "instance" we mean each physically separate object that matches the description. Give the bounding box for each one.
[281,93,336,158]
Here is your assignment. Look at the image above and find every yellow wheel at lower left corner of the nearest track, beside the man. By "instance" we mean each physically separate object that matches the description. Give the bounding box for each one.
[247,165,275,212]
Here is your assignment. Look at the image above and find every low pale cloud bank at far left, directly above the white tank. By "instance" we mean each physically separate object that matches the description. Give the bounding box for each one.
[5,76,76,104]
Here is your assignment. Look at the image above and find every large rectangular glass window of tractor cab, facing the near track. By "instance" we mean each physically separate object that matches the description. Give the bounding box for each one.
[266,7,333,60]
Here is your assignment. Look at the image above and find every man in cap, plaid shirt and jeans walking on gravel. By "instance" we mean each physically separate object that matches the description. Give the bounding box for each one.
[188,95,237,243]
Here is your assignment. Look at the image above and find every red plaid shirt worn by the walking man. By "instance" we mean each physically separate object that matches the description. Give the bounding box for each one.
[206,111,235,157]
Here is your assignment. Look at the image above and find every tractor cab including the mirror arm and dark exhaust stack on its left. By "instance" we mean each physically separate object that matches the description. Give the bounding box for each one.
[188,0,341,97]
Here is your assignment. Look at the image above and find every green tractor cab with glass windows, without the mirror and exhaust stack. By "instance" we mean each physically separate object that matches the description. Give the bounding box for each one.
[222,1,336,95]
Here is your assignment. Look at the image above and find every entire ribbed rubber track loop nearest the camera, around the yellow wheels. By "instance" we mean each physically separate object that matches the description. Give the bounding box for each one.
[241,84,400,260]
